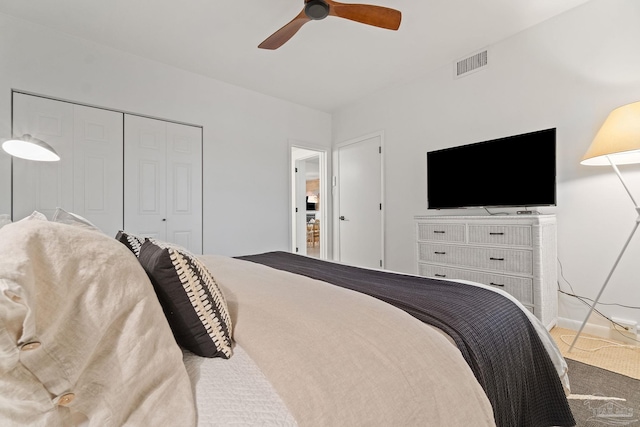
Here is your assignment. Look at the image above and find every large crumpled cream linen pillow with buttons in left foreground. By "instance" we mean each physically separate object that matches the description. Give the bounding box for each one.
[0,221,196,427]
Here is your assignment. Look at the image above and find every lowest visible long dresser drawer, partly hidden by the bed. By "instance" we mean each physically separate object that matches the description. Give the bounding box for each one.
[418,263,534,305]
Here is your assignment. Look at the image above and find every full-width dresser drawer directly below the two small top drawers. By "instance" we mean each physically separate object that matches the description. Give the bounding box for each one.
[418,242,533,274]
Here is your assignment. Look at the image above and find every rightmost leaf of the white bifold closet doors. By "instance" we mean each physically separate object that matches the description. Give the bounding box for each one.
[167,123,202,254]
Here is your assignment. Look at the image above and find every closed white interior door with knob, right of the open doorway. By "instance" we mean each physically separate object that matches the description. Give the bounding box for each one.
[337,135,384,268]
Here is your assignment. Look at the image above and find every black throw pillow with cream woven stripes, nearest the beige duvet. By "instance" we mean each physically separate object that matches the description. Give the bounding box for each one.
[138,239,232,359]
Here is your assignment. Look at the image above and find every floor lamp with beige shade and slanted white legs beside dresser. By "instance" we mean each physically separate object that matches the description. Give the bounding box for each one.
[569,102,640,351]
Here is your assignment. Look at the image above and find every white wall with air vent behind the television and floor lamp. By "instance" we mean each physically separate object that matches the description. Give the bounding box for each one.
[333,0,640,332]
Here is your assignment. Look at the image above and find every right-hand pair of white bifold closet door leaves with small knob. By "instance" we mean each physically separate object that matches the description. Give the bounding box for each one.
[124,114,202,253]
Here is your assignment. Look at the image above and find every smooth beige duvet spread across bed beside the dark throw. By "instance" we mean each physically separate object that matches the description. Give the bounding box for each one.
[201,255,494,427]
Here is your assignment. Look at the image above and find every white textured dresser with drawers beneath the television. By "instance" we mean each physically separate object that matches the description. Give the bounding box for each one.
[415,215,558,329]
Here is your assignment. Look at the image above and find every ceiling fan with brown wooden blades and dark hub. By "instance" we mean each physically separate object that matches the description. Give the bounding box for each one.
[258,0,402,50]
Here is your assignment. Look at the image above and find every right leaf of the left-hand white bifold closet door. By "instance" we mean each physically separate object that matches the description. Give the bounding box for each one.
[73,105,124,236]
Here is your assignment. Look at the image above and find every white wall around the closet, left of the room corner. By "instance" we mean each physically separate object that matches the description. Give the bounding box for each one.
[0,14,331,255]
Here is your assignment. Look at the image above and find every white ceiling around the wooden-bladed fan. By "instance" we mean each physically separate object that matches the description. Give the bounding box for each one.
[0,0,588,112]
